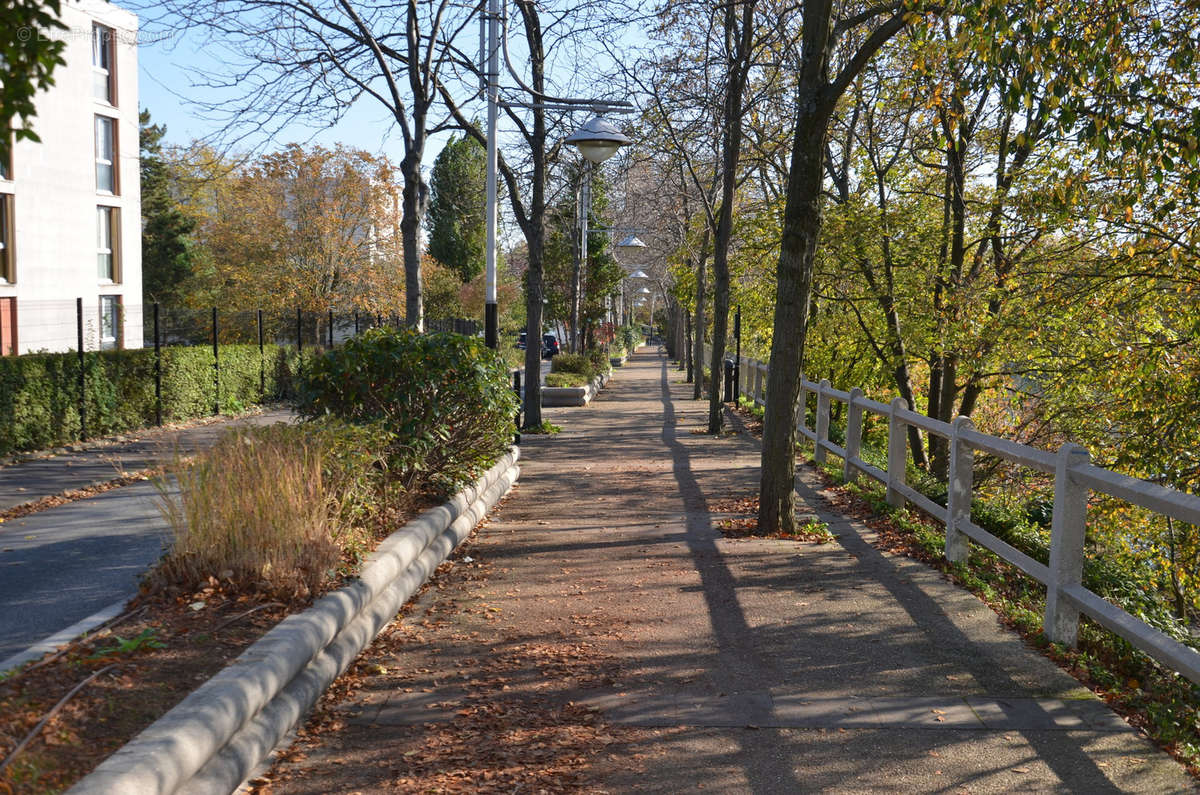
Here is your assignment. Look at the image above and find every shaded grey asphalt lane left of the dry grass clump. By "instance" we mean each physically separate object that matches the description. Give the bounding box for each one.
[0,483,167,660]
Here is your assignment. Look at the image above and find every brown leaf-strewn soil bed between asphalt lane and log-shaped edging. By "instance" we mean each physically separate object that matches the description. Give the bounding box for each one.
[0,584,288,793]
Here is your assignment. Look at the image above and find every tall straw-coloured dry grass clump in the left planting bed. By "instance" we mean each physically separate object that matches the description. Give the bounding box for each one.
[150,424,377,599]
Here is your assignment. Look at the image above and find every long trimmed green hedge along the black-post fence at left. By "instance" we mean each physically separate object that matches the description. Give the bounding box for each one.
[0,345,320,455]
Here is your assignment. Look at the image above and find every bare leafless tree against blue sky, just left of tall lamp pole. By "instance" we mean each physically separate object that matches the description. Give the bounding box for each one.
[133,0,473,329]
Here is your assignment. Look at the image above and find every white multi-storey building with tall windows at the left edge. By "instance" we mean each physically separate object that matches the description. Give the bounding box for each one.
[0,0,142,355]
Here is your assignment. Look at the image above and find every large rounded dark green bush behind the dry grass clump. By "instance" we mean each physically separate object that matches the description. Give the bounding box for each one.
[298,329,517,491]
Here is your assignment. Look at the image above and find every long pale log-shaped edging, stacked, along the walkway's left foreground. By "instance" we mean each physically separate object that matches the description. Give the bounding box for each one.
[70,448,520,795]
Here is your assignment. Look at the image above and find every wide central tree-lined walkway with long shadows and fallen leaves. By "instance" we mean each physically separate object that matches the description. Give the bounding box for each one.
[255,348,1195,794]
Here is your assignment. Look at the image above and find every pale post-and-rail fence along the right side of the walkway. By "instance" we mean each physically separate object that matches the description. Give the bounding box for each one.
[720,357,1200,683]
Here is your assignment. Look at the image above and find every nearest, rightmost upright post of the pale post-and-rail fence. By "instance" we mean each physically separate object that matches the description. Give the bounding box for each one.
[1043,442,1090,646]
